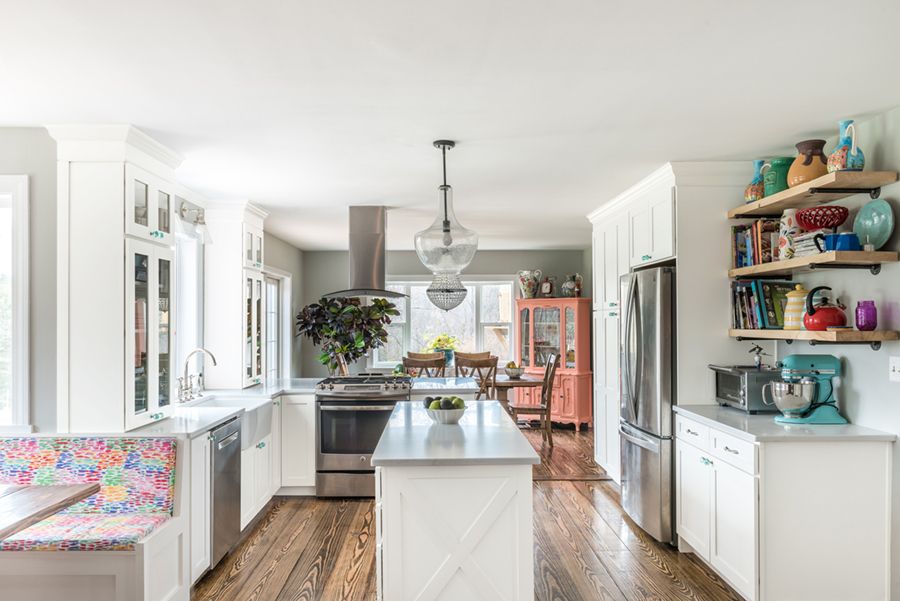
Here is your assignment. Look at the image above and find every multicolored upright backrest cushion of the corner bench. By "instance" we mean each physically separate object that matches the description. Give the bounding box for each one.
[0,437,176,515]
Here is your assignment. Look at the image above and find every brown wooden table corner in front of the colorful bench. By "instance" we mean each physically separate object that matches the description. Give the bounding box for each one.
[0,482,100,540]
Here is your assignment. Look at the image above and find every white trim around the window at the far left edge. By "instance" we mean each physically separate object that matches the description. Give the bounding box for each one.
[0,175,33,433]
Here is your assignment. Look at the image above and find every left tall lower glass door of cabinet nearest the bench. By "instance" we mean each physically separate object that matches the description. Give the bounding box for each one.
[130,251,150,415]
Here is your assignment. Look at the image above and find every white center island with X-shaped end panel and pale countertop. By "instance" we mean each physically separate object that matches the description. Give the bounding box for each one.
[372,401,540,601]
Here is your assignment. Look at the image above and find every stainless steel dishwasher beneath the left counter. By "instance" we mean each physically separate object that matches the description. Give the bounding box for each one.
[210,418,241,568]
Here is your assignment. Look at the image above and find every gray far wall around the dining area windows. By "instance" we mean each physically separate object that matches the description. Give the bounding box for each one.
[298,248,591,377]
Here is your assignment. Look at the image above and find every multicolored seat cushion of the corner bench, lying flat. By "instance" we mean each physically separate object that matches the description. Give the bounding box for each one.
[0,513,169,551]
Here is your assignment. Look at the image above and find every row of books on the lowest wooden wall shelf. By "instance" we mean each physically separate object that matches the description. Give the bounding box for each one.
[731,280,794,330]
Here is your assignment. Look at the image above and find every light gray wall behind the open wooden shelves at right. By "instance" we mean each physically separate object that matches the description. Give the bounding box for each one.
[768,109,900,599]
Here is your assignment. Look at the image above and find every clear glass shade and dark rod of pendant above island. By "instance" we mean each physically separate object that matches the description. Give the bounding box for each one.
[416,140,478,274]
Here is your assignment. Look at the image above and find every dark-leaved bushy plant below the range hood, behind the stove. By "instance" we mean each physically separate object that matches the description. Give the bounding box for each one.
[297,298,400,376]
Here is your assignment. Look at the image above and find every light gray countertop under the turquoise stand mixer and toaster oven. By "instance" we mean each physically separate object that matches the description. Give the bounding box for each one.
[673,405,897,443]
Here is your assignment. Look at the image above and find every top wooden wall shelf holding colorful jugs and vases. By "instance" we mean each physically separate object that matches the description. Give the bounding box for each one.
[728,171,897,219]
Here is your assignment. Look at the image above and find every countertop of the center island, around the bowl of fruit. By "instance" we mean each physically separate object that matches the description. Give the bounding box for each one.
[372,401,540,466]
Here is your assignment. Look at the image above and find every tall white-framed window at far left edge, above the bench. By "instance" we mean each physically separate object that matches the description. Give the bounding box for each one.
[0,175,29,430]
